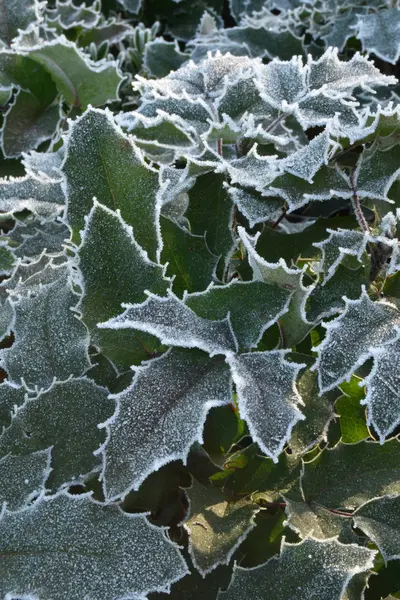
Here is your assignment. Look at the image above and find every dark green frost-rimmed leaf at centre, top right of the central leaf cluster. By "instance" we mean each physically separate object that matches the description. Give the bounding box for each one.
[184,280,292,349]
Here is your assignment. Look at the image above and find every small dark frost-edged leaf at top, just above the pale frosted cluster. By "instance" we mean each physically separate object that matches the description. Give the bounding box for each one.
[143,38,189,77]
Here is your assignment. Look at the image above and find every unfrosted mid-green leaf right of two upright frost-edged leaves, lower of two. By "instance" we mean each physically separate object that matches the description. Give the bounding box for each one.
[160,217,218,296]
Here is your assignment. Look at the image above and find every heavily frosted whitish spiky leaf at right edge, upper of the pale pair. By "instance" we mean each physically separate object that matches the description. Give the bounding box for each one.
[315,288,400,392]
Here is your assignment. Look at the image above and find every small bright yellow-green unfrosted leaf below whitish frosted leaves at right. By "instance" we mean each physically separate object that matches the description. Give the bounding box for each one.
[335,375,369,444]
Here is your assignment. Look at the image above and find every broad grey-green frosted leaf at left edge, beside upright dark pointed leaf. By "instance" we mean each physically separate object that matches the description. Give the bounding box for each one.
[2,267,90,388]
